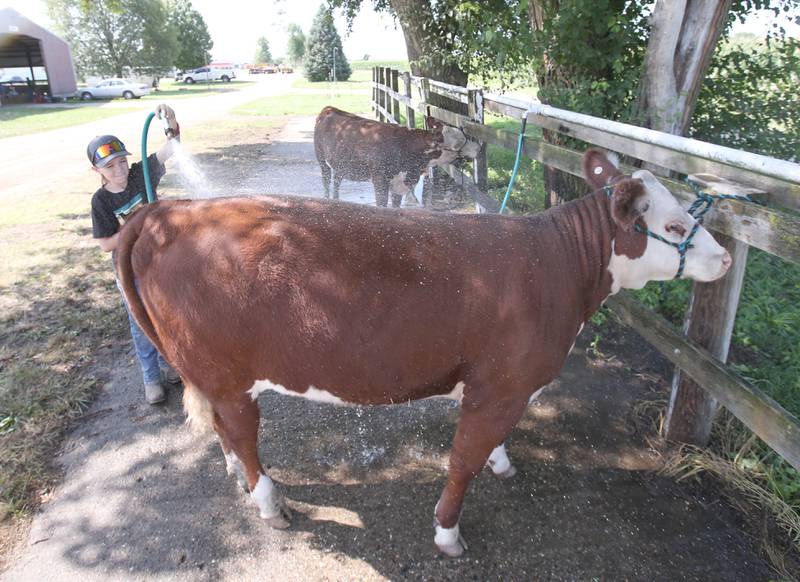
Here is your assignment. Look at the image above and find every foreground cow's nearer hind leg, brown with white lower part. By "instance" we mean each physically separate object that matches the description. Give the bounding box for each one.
[214,393,291,529]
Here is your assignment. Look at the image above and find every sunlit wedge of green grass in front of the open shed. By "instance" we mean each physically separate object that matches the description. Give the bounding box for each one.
[0,103,136,138]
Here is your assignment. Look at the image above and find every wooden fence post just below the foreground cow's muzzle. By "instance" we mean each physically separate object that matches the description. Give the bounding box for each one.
[665,175,763,447]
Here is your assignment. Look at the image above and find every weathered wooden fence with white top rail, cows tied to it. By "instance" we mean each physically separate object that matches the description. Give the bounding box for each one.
[373,67,800,470]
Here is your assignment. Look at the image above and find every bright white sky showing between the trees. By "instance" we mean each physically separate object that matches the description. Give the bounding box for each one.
[0,0,800,63]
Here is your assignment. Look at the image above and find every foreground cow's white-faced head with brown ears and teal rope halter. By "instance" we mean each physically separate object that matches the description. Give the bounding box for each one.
[584,150,731,292]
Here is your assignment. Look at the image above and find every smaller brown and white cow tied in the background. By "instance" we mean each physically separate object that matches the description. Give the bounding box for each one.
[314,107,478,208]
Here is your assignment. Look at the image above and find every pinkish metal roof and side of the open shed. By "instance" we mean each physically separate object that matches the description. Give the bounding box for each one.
[0,8,78,97]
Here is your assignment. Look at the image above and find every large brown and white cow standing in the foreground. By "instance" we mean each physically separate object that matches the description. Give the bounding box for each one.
[118,151,731,556]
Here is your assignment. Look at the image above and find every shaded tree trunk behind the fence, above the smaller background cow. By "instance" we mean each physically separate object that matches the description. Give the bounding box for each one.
[391,0,468,87]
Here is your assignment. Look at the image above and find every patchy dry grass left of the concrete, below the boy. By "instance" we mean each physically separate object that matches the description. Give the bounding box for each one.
[0,224,127,515]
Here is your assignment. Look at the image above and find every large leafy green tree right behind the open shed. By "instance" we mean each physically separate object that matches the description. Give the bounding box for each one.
[47,0,178,77]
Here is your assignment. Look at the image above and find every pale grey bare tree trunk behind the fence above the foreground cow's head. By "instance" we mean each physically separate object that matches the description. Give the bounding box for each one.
[637,0,731,135]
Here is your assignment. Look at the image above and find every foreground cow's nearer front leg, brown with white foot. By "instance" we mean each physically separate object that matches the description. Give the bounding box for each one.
[434,394,525,557]
